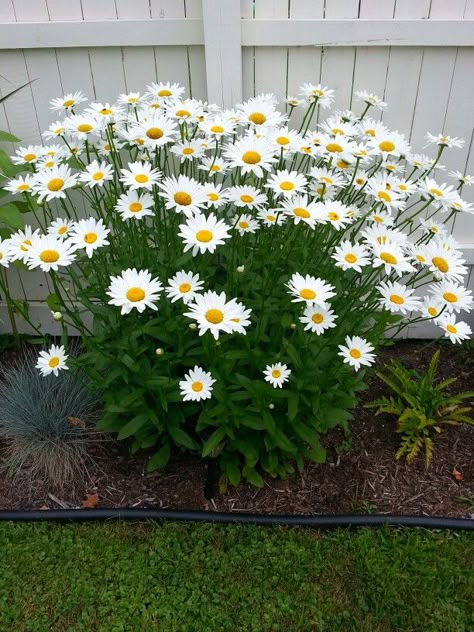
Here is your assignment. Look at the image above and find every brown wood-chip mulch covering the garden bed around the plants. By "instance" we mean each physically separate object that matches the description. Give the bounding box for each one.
[0,341,474,517]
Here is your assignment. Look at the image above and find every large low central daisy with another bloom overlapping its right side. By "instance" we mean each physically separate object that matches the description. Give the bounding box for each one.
[184,291,251,340]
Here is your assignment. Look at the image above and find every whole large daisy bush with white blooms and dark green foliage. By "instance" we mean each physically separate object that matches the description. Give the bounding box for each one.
[0,83,473,485]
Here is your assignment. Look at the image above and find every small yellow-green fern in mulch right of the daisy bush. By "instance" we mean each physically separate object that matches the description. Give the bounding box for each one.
[366,351,474,465]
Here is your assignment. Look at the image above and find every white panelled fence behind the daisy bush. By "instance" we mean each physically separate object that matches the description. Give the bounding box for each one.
[0,0,474,335]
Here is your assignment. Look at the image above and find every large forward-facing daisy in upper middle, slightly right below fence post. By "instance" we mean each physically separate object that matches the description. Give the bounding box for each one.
[224,135,276,178]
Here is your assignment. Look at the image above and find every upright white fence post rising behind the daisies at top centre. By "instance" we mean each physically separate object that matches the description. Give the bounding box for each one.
[202,0,242,108]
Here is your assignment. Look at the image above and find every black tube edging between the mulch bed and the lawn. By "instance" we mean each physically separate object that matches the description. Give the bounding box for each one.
[0,509,474,531]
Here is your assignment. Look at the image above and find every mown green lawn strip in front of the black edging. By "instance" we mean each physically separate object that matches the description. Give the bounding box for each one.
[0,523,474,632]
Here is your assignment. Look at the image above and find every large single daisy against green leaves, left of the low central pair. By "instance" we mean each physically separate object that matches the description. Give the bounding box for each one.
[107,268,163,315]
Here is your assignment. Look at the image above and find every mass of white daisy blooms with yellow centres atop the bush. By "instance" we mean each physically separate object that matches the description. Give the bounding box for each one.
[0,83,474,392]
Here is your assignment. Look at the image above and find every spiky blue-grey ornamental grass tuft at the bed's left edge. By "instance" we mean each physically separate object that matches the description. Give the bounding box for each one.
[0,352,99,486]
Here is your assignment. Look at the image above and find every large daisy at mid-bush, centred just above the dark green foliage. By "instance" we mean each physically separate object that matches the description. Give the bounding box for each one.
[178,213,230,257]
